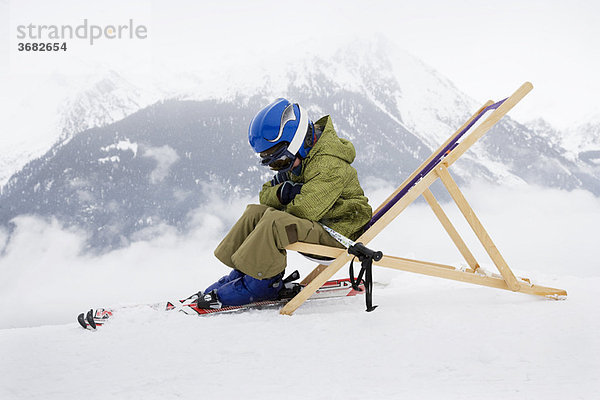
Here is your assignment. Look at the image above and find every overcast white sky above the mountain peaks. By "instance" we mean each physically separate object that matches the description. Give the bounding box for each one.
[0,0,600,125]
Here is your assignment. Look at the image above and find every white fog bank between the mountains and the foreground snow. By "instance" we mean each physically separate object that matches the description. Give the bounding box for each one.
[0,180,600,328]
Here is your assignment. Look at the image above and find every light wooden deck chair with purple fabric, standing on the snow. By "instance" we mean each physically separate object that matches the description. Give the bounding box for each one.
[281,82,567,315]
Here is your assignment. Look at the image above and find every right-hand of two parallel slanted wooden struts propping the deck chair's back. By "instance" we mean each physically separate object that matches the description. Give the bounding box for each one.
[435,164,520,291]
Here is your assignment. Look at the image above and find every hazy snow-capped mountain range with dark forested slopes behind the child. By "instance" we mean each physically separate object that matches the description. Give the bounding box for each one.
[0,40,600,249]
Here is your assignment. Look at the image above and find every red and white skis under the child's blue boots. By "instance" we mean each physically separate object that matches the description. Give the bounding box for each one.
[77,278,365,330]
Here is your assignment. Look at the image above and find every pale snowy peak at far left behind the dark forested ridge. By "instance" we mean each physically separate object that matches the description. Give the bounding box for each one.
[0,71,161,190]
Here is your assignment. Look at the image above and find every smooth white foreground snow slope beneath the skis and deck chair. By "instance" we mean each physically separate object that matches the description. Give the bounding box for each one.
[0,276,600,400]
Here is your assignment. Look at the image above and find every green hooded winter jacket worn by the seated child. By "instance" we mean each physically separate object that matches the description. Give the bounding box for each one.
[259,115,372,240]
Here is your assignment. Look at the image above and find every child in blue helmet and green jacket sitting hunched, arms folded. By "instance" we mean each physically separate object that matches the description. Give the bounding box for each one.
[198,99,371,308]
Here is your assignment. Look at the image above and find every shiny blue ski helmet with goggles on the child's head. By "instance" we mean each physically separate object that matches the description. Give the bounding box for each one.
[248,98,314,171]
